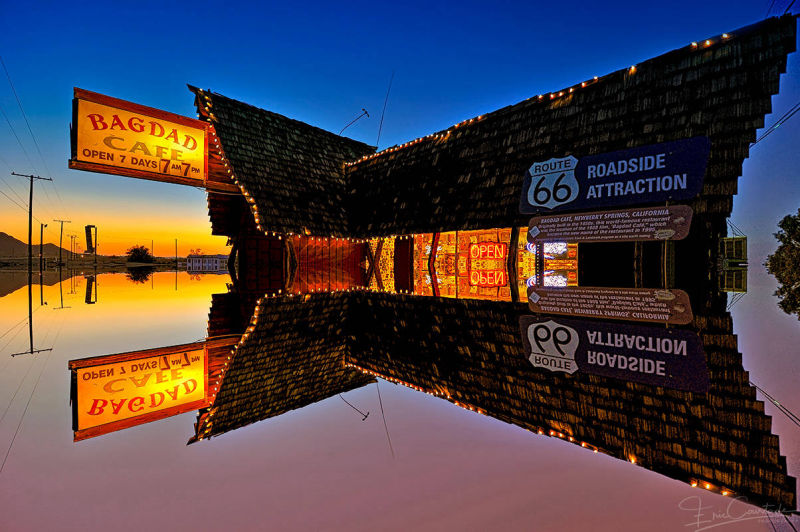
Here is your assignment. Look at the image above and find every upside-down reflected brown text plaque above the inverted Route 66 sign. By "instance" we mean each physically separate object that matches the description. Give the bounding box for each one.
[528,286,692,325]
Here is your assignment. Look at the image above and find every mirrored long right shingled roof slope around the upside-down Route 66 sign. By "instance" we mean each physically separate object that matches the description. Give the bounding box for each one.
[347,293,796,508]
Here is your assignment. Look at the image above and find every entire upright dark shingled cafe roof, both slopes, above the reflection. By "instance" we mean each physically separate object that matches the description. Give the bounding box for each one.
[191,15,796,241]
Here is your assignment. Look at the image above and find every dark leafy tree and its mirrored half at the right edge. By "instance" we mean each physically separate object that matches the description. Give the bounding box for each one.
[764,209,800,319]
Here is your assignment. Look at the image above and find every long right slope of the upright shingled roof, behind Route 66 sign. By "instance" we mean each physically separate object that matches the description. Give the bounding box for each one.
[347,15,796,236]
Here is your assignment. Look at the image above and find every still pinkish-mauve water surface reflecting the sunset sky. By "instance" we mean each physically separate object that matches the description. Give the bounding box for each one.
[0,270,800,530]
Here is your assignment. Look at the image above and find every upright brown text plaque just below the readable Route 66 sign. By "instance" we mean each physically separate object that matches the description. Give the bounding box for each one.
[528,205,692,242]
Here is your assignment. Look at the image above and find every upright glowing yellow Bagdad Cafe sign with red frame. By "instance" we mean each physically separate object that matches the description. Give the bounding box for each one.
[69,88,208,186]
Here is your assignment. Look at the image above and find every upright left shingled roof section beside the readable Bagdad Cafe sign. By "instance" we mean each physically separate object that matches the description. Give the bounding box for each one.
[189,86,375,236]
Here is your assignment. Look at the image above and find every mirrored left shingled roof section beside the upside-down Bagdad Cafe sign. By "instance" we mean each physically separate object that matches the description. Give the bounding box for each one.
[190,294,375,443]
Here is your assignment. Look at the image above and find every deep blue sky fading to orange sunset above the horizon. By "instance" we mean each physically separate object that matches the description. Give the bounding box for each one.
[0,0,800,255]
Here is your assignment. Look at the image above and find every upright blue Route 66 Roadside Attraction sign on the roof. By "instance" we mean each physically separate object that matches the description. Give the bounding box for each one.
[519,137,711,214]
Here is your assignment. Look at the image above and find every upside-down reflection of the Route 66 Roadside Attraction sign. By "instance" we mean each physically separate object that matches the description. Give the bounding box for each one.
[520,316,709,393]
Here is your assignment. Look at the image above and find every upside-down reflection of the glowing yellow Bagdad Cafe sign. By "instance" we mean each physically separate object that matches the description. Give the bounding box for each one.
[69,342,209,441]
